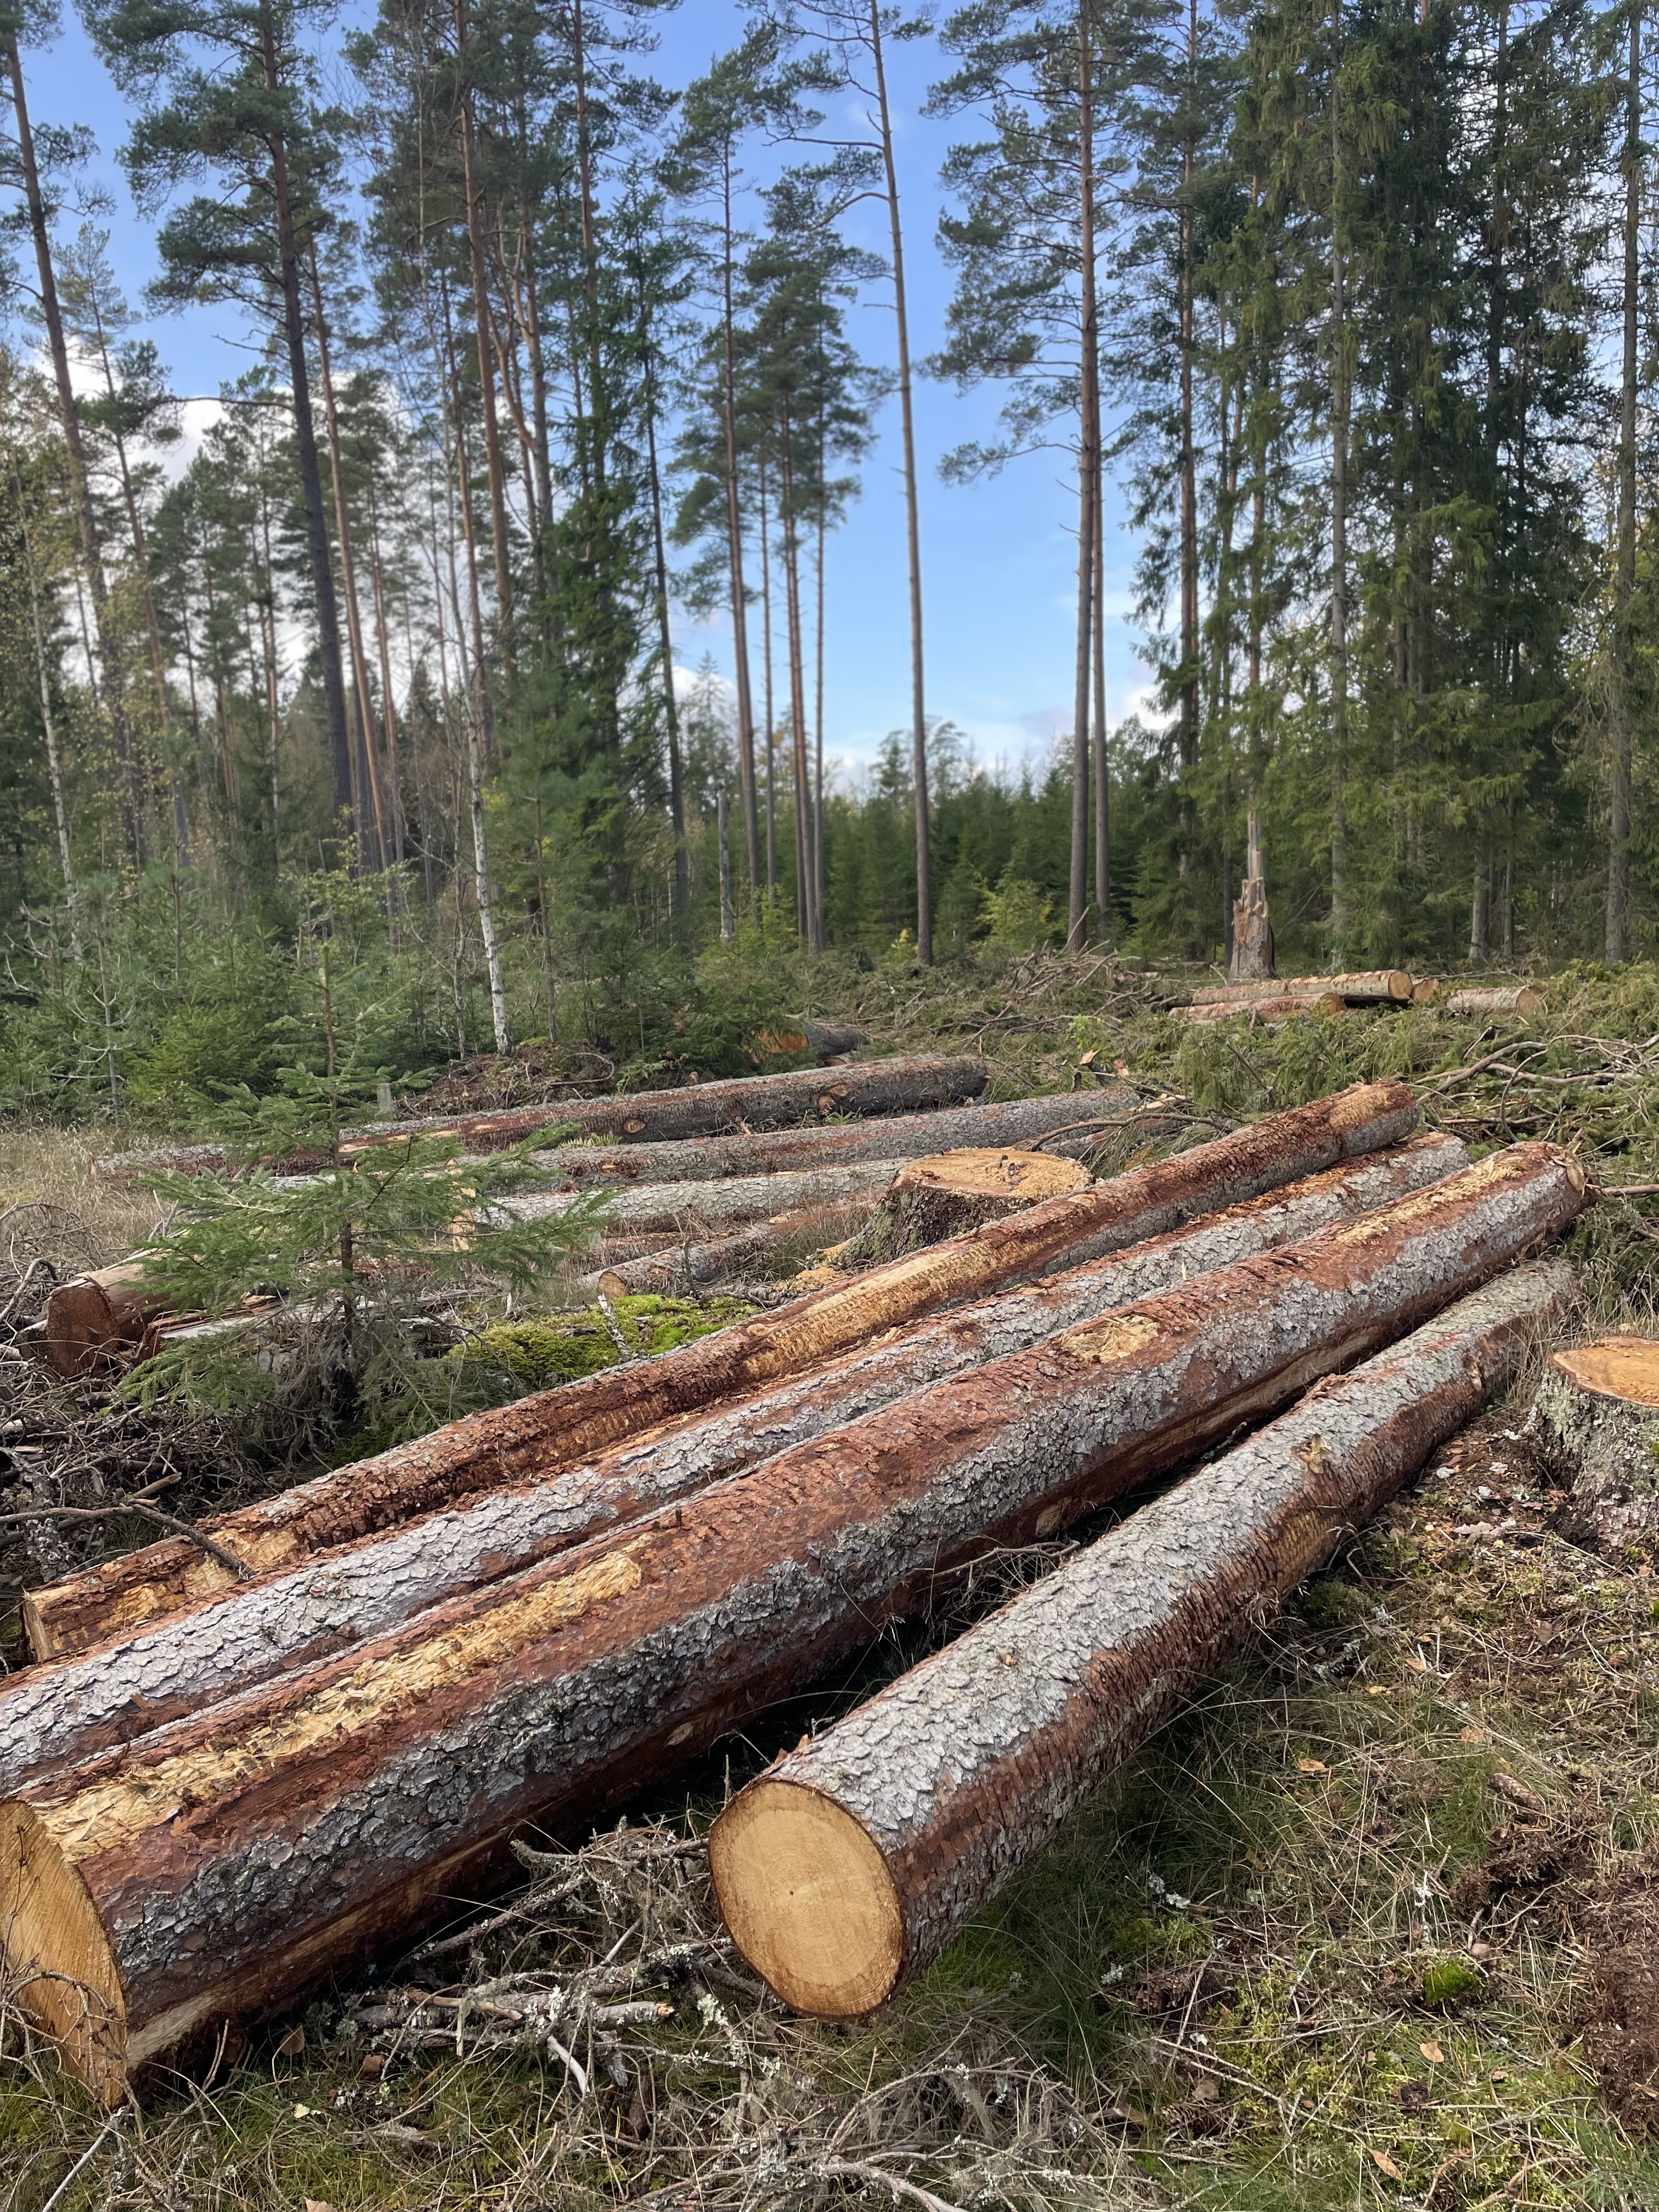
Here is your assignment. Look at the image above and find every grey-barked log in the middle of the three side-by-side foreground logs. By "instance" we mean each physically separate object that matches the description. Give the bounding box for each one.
[0,1137,1466,1790]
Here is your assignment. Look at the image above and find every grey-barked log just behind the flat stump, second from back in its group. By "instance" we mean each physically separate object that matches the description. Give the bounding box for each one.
[538,1088,1157,1190]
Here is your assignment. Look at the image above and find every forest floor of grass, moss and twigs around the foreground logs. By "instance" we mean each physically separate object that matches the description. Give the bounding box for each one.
[0,962,1659,2212]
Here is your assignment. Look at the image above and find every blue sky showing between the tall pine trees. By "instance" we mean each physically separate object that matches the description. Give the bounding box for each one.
[26,0,1146,792]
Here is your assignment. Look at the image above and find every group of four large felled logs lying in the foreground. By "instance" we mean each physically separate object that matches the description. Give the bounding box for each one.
[0,1084,1586,2103]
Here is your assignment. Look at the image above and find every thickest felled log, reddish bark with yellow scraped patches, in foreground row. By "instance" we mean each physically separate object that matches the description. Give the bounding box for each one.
[0,1144,1584,2103]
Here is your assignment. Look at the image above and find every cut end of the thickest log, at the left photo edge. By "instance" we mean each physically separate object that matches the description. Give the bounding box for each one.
[0,1801,126,2108]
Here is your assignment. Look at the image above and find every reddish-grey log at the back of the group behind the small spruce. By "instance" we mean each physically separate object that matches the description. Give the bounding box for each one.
[104,1055,986,1175]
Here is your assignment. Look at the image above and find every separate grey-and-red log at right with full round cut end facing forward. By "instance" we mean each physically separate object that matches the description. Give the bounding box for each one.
[708,1265,1573,2019]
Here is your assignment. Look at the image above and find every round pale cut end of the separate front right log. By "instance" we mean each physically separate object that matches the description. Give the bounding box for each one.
[708,1779,905,2019]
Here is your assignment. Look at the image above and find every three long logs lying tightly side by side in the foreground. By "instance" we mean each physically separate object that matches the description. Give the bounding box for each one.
[0,1084,1584,2101]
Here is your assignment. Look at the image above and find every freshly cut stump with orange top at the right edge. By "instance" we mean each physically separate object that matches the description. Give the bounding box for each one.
[1535,1336,1659,1550]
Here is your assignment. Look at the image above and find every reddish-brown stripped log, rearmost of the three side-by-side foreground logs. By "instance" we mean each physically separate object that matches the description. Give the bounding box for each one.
[22,1082,1418,1659]
